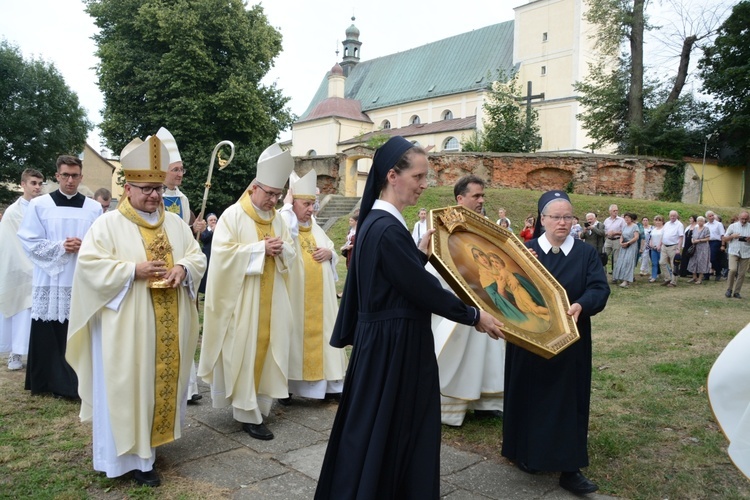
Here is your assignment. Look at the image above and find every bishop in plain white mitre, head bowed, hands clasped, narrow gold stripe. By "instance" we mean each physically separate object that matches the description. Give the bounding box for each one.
[198,144,295,440]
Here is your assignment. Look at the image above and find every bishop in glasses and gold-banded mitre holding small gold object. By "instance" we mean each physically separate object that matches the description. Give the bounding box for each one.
[66,136,206,486]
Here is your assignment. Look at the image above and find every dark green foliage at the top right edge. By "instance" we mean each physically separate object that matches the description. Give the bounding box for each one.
[699,0,750,165]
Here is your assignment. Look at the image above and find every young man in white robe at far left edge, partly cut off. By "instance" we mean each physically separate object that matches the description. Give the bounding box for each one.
[0,168,44,370]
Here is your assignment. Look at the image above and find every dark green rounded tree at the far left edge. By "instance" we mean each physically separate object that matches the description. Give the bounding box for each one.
[0,41,91,203]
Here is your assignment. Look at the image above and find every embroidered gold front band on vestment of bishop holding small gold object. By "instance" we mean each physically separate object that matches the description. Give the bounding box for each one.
[117,197,180,447]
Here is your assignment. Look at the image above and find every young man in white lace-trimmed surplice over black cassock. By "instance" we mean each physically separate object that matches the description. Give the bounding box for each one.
[18,155,102,400]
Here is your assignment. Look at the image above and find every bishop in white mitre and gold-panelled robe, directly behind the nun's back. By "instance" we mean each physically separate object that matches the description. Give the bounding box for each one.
[279,170,347,404]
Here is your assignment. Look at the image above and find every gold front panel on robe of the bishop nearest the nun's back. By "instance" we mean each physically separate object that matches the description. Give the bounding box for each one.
[299,225,324,381]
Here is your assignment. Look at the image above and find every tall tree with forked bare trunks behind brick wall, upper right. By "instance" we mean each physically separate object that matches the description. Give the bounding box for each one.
[574,0,720,158]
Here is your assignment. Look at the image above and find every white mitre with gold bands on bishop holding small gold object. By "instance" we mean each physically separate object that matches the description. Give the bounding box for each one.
[120,136,169,183]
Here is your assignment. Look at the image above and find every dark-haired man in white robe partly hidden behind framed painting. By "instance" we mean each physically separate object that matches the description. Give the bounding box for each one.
[429,175,505,426]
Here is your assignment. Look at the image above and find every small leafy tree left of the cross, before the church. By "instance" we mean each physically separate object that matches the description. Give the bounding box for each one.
[462,72,542,153]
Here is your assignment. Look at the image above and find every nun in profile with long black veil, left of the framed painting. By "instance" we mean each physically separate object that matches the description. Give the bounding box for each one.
[315,137,502,500]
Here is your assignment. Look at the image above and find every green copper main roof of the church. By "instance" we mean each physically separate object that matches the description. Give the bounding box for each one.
[300,21,514,120]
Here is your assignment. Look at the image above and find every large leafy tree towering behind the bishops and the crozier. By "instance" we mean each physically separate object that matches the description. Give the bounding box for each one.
[86,0,294,212]
